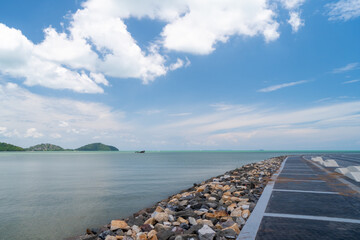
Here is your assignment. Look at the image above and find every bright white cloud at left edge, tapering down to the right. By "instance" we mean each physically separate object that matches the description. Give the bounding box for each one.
[0,23,103,93]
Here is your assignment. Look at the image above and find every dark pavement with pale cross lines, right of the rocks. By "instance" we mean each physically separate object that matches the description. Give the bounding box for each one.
[238,154,360,240]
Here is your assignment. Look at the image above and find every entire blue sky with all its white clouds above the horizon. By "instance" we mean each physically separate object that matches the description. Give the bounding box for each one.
[0,0,360,150]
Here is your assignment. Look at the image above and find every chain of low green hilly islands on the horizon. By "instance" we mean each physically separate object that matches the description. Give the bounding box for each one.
[0,142,119,152]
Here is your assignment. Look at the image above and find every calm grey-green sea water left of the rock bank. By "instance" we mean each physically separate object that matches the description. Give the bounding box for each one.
[0,152,354,240]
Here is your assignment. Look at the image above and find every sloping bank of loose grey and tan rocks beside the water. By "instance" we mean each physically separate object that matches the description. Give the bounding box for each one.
[67,156,285,240]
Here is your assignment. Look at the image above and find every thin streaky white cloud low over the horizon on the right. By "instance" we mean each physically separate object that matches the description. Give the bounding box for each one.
[154,101,360,149]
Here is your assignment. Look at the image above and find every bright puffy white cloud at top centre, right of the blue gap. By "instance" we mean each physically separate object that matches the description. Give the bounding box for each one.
[161,0,279,54]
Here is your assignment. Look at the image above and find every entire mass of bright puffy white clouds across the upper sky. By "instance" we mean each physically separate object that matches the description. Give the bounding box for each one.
[0,0,304,93]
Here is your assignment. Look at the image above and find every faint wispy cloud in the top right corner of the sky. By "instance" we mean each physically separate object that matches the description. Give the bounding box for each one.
[326,0,360,21]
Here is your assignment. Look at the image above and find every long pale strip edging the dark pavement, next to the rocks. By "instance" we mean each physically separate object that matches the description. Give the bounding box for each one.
[237,157,288,240]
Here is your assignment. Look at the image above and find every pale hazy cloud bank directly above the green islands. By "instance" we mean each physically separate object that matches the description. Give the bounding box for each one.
[0,83,132,144]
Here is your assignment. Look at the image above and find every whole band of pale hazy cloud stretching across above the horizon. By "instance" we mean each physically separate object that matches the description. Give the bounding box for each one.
[0,80,360,150]
